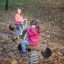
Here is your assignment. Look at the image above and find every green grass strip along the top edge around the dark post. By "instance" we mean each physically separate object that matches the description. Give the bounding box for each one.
[0,0,38,9]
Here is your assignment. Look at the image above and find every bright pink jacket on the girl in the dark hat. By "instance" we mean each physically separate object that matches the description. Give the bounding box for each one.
[27,28,40,46]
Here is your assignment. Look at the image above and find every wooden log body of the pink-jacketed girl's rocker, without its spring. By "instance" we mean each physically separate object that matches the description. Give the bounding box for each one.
[18,44,52,59]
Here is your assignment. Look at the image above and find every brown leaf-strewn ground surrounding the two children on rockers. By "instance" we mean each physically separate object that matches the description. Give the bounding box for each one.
[0,0,64,64]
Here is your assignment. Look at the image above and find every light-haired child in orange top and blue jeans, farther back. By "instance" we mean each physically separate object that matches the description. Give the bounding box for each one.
[15,9,26,35]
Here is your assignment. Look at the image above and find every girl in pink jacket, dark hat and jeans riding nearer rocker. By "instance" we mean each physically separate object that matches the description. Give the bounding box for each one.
[20,20,40,53]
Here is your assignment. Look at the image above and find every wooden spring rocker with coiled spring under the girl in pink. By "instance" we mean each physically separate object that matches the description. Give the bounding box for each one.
[18,40,52,64]
